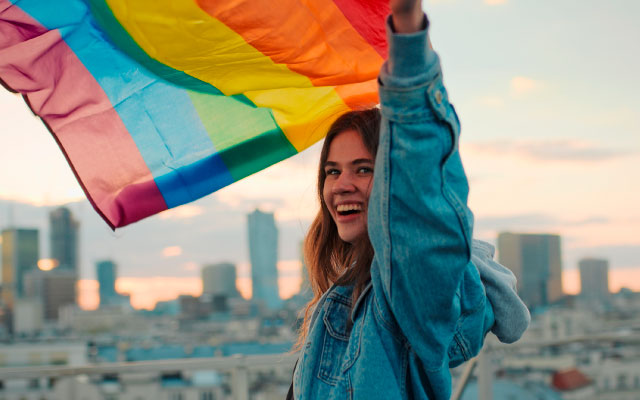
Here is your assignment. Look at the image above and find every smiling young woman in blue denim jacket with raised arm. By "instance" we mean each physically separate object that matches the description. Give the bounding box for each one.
[293,0,529,400]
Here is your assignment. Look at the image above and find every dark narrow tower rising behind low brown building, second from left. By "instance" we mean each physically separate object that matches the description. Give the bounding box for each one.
[49,207,79,275]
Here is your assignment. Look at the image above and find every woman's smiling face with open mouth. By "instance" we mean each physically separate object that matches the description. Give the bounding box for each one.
[322,130,374,243]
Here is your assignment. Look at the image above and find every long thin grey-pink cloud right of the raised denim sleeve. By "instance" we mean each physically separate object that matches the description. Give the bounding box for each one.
[466,139,633,162]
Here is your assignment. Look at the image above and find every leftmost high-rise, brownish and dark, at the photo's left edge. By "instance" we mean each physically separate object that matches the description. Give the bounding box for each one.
[2,228,40,310]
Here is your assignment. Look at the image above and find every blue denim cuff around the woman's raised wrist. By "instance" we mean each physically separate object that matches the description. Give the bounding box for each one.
[380,15,440,87]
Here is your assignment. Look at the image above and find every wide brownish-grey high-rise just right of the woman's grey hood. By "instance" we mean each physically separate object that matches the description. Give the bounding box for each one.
[498,232,563,309]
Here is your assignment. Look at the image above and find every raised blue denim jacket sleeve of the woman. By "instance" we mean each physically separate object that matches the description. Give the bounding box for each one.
[368,17,494,370]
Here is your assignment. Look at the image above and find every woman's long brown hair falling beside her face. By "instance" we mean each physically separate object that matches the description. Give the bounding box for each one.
[295,108,380,350]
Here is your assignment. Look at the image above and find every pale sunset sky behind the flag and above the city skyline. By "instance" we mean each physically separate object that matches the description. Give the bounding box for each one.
[0,0,640,307]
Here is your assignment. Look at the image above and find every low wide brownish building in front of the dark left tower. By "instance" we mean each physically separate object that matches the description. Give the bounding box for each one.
[24,268,77,321]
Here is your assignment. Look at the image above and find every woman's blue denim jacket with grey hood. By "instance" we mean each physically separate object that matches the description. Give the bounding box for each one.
[293,15,529,400]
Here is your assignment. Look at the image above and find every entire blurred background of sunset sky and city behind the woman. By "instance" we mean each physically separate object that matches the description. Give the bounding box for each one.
[0,0,640,400]
